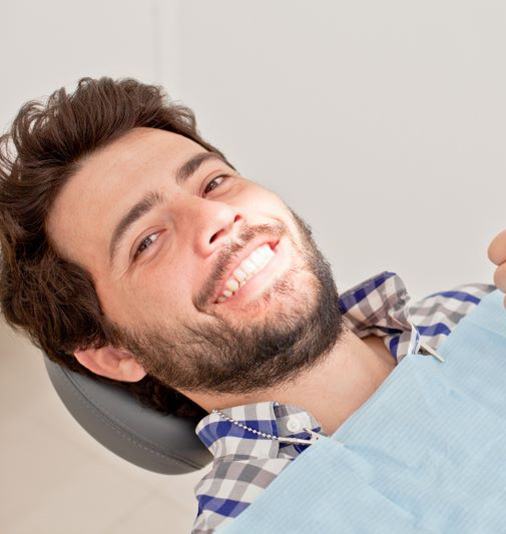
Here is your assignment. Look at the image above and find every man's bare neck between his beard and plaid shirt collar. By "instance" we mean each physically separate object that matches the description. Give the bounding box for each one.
[183,330,395,435]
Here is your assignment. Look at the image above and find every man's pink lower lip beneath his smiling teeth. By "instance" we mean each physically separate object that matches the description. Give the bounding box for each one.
[216,239,290,306]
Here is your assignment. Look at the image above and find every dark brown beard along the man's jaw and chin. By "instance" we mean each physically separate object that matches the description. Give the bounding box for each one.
[107,210,343,393]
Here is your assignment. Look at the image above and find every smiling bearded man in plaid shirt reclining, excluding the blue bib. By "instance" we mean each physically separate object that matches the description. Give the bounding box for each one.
[0,78,506,532]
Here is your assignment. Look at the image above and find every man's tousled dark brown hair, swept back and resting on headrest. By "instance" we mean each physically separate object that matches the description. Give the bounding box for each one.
[0,77,233,419]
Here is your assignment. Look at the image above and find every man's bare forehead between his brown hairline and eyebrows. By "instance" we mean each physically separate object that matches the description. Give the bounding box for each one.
[47,128,205,272]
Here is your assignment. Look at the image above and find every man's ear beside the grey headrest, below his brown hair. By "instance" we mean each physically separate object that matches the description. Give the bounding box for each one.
[74,345,147,382]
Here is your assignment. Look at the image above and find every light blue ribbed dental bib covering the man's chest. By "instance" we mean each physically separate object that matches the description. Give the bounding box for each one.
[217,290,506,534]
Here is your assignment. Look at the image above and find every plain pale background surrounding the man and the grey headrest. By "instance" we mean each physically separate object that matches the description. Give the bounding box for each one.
[0,0,506,534]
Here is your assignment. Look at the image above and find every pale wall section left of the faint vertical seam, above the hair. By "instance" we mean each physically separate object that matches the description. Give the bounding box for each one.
[0,0,179,130]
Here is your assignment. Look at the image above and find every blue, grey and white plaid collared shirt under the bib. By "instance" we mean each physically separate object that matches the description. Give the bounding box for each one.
[192,271,495,534]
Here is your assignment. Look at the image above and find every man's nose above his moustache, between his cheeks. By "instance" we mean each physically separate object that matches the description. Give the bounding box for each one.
[189,199,244,257]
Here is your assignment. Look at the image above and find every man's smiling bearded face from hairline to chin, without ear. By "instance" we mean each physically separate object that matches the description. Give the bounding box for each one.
[48,128,342,393]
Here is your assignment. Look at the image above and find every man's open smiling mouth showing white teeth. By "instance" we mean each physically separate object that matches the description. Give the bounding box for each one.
[215,241,280,304]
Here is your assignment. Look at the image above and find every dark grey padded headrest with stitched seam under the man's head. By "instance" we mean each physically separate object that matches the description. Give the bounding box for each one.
[44,355,212,475]
